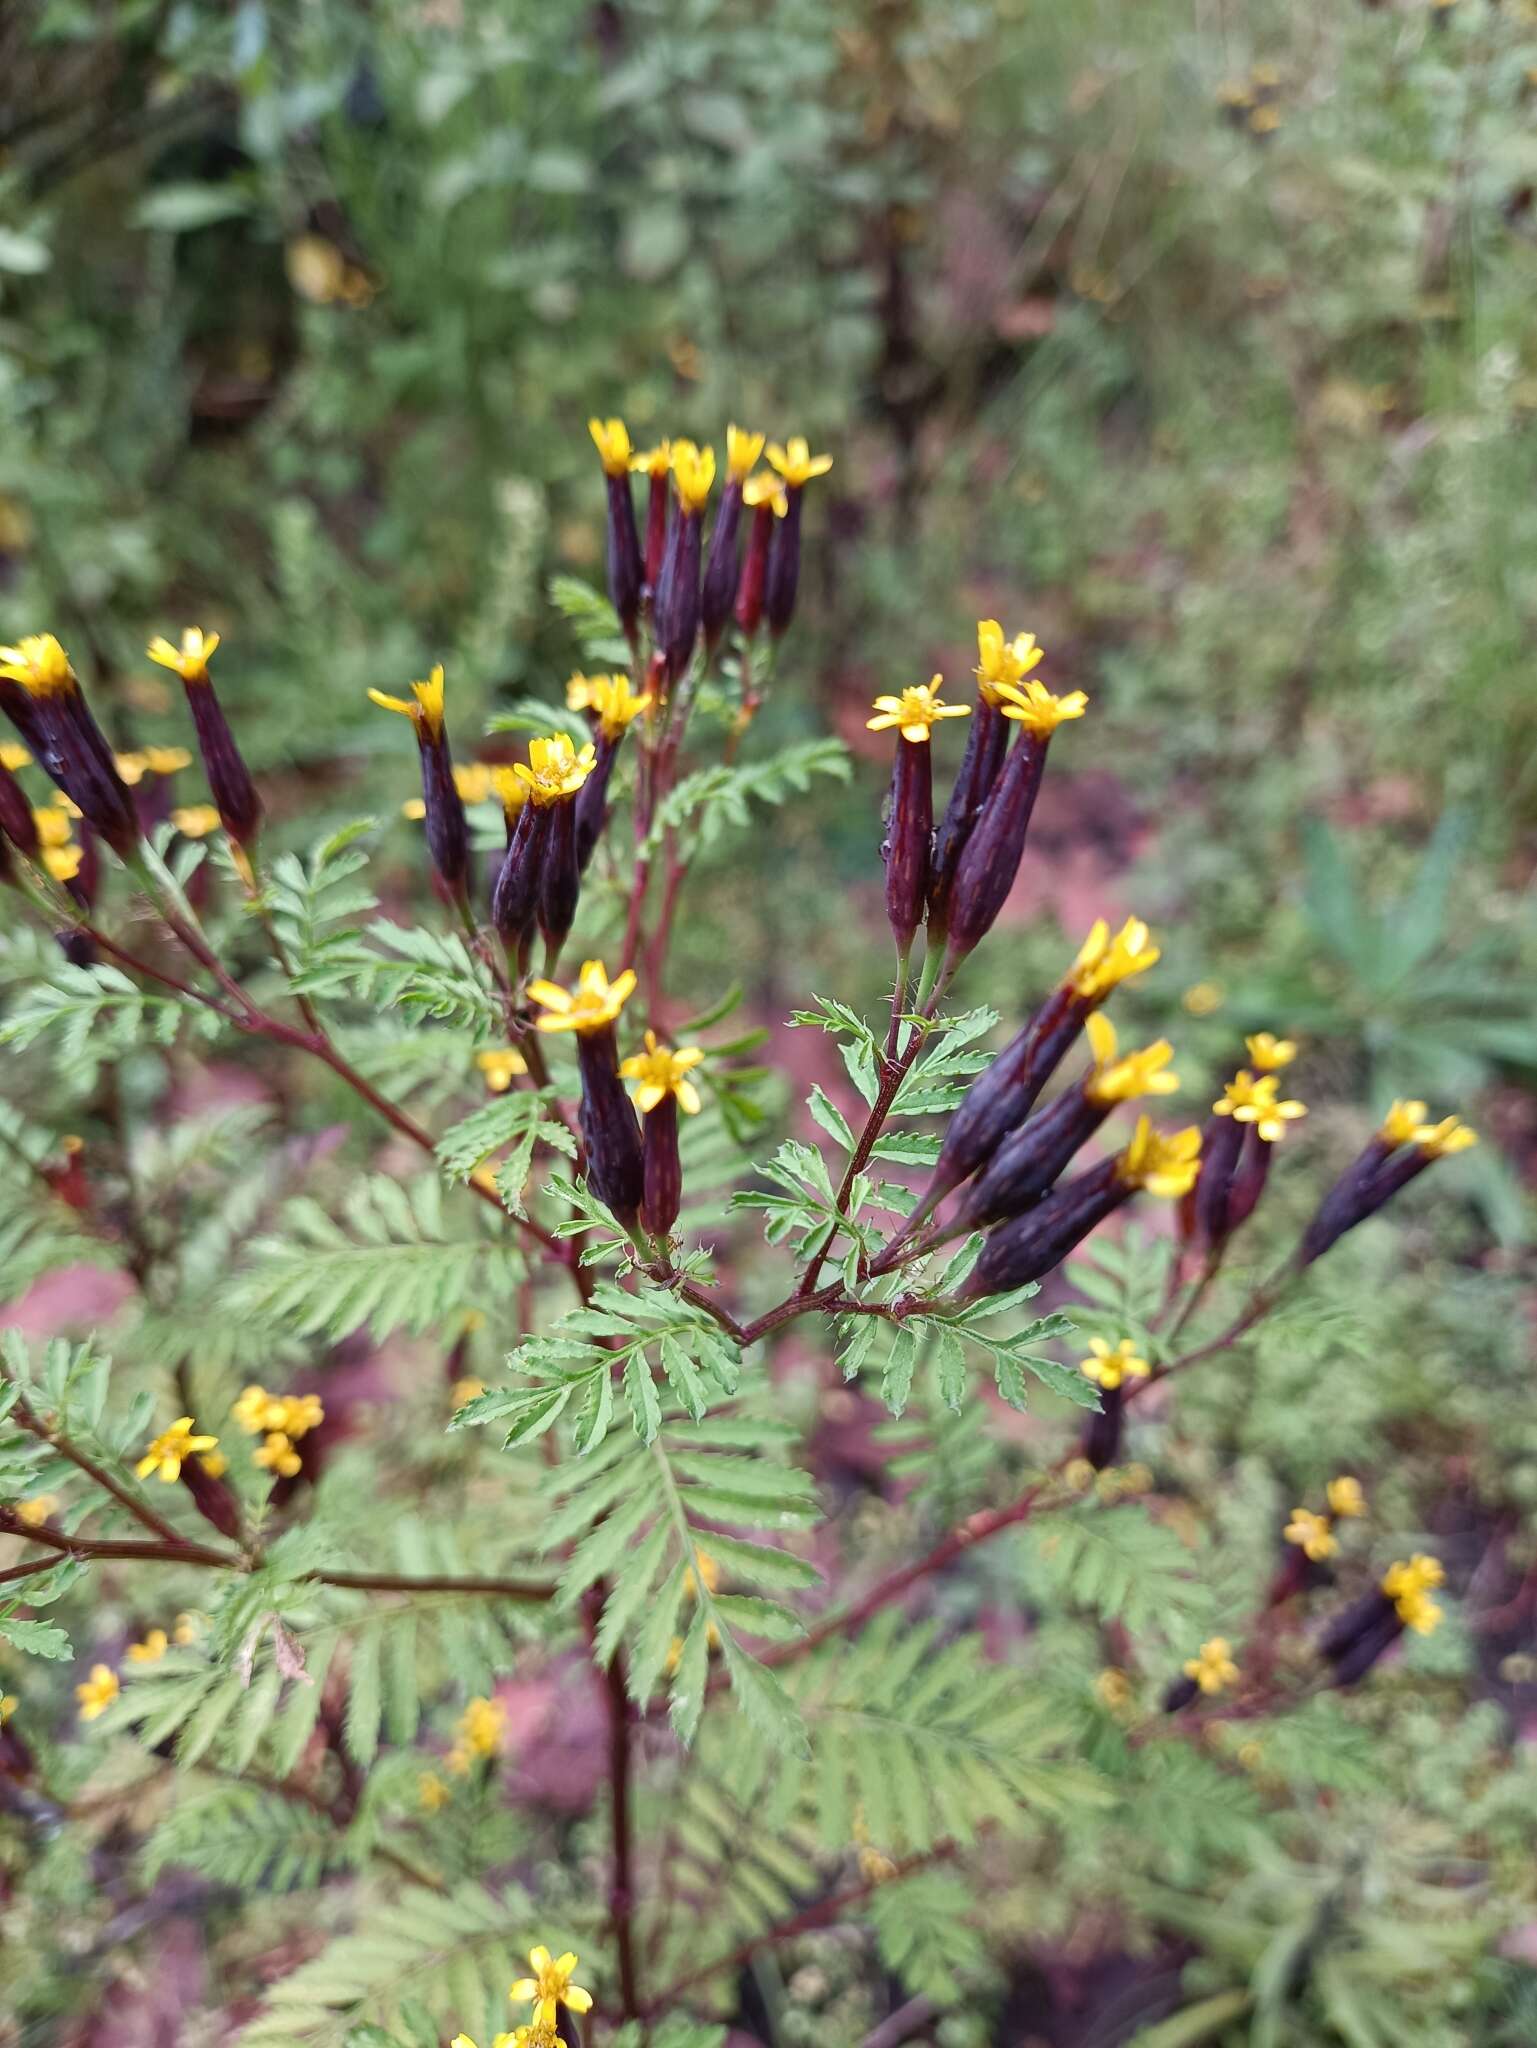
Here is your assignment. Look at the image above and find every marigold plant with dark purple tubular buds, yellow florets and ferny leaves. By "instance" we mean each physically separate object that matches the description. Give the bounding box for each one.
[0,391,1473,2048]
